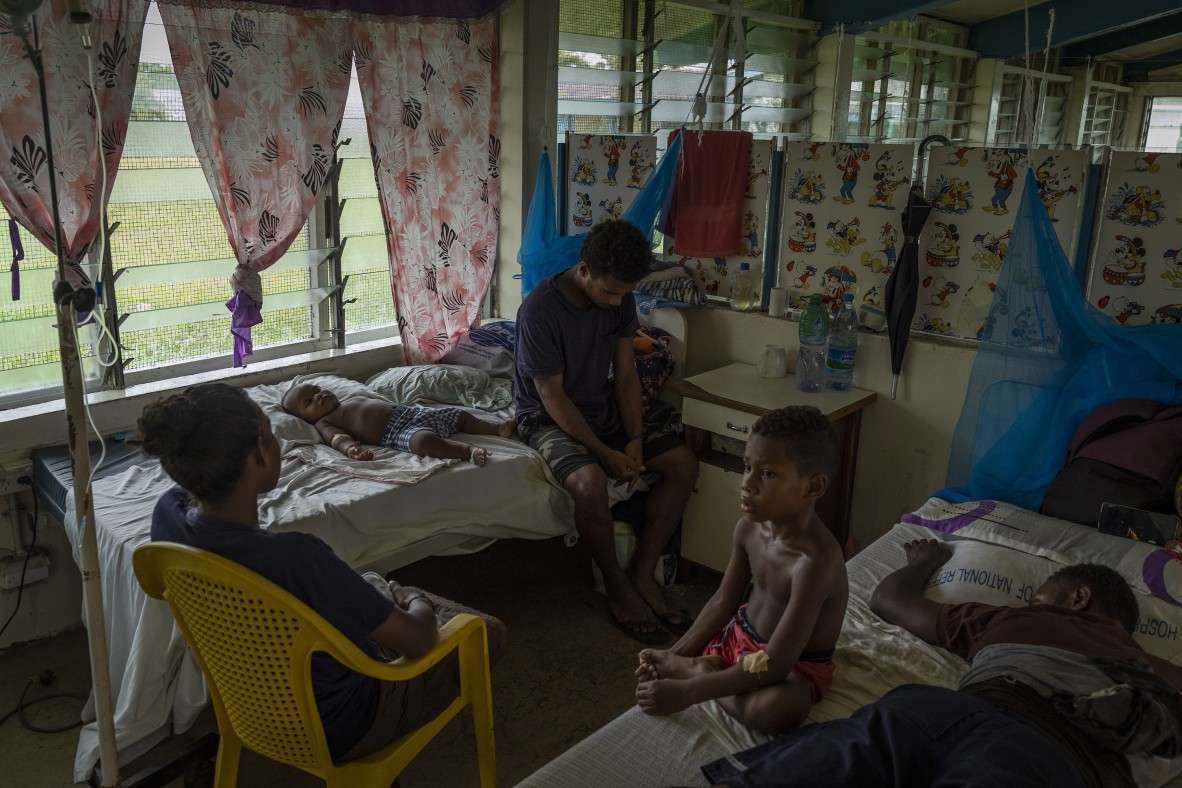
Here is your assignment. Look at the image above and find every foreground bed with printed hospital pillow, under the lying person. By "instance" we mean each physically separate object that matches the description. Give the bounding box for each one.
[519,499,1182,788]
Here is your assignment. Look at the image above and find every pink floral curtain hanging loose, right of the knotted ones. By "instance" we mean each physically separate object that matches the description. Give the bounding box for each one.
[353,18,501,363]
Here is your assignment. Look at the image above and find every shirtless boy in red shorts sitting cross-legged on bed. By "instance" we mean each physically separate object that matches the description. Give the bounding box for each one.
[636,405,850,734]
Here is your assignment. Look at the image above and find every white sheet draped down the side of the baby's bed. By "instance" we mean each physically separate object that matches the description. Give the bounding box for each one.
[65,436,573,782]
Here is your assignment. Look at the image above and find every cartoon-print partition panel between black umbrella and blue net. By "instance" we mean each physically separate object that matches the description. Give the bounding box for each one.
[911,146,1087,340]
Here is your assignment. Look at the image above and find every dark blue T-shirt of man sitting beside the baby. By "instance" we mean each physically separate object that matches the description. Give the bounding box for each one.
[513,274,639,436]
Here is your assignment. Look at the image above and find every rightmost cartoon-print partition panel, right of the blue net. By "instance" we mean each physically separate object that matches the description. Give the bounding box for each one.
[1087,151,1182,326]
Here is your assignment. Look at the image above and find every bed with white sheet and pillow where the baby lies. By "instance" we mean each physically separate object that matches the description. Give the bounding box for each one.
[59,310,686,781]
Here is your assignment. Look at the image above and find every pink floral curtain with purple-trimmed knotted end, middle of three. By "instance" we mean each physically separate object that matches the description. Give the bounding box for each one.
[160,0,352,366]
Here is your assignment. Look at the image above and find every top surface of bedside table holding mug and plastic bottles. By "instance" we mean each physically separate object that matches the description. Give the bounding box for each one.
[674,364,878,421]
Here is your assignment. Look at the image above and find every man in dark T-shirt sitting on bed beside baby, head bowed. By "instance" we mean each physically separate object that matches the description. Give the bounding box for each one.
[514,221,697,645]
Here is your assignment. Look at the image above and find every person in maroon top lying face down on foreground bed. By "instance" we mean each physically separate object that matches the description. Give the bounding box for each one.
[702,540,1182,788]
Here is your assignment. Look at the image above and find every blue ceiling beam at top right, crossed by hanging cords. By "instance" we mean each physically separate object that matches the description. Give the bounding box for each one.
[968,0,1178,58]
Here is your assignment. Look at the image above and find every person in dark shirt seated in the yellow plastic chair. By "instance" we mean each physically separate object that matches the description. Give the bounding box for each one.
[132,383,505,761]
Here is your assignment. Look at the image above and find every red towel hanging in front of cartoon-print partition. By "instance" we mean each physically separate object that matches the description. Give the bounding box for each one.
[660,129,752,258]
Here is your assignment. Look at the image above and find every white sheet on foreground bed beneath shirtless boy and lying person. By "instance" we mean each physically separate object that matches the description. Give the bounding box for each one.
[518,499,1182,788]
